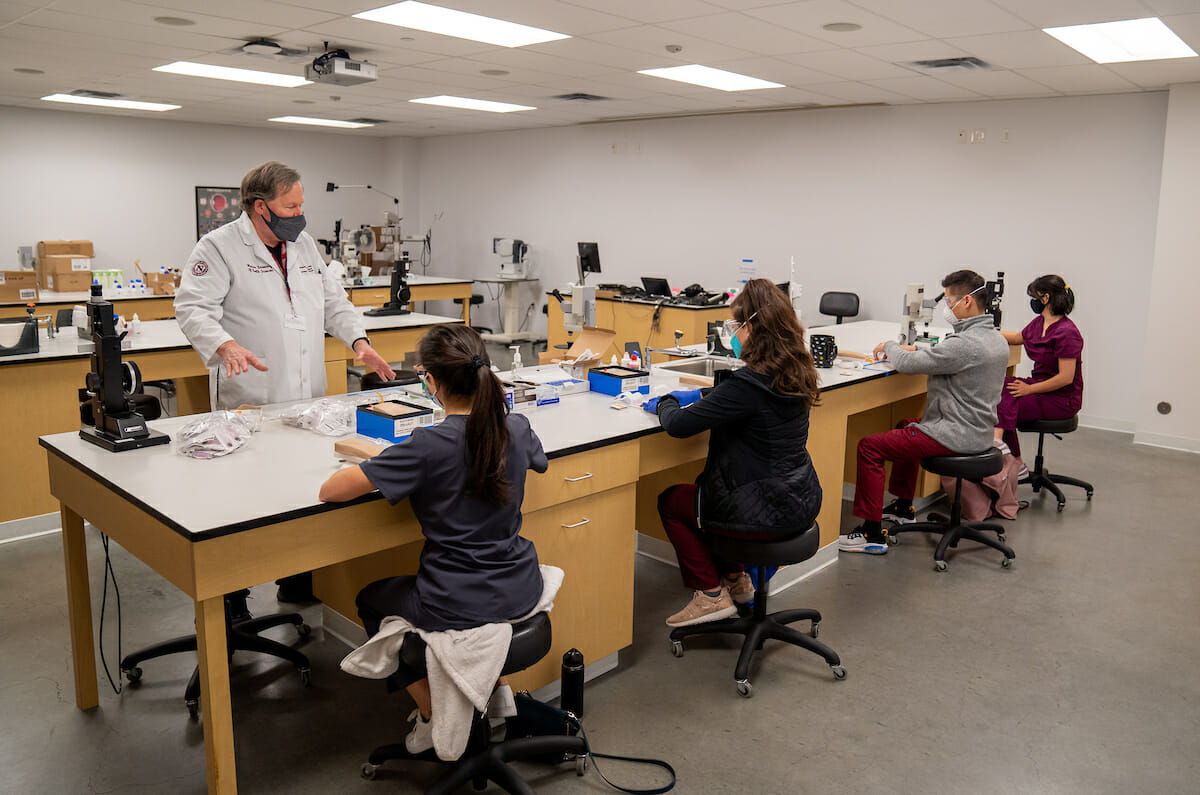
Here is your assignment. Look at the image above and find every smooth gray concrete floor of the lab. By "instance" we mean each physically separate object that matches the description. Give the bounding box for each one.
[0,430,1200,795]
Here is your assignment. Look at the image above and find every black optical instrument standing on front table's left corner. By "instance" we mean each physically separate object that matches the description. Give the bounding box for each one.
[79,285,170,453]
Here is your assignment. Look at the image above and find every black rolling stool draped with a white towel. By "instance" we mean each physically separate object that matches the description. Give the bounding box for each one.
[361,612,588,795]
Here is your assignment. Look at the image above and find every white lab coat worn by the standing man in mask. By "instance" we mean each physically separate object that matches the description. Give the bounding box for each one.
[175,213,366,408]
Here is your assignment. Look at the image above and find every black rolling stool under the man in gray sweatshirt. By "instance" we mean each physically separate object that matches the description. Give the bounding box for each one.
[888,447,1016,572]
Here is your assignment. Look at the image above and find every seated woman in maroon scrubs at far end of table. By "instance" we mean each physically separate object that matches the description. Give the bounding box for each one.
[996,275,1084,456]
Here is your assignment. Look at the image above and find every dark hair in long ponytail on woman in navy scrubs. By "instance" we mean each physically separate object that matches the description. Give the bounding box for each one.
[418,324,512,506]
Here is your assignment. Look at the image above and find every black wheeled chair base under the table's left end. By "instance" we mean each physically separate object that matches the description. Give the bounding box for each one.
[121,590,312,719]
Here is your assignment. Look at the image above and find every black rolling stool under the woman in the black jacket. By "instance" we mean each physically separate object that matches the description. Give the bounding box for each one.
[671,522,846,698]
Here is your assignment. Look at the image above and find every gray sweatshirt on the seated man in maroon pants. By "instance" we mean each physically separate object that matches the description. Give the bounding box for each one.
[883,315,1008,453]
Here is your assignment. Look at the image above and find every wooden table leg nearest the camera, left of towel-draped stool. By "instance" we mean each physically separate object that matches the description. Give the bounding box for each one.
[196,596,238,795]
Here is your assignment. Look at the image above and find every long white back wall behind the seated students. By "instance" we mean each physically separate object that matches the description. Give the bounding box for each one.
[420,94,1166,430]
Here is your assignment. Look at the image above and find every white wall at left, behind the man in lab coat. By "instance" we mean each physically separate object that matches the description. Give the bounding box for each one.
[0,107,403,279]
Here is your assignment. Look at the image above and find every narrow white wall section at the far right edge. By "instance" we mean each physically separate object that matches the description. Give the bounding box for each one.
[1134,83,1200,450]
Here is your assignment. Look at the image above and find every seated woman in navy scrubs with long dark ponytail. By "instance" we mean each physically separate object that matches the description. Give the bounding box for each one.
[320,325,548,753]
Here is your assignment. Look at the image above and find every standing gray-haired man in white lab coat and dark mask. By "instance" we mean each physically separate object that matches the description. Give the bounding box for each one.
[175,162,395,408]
